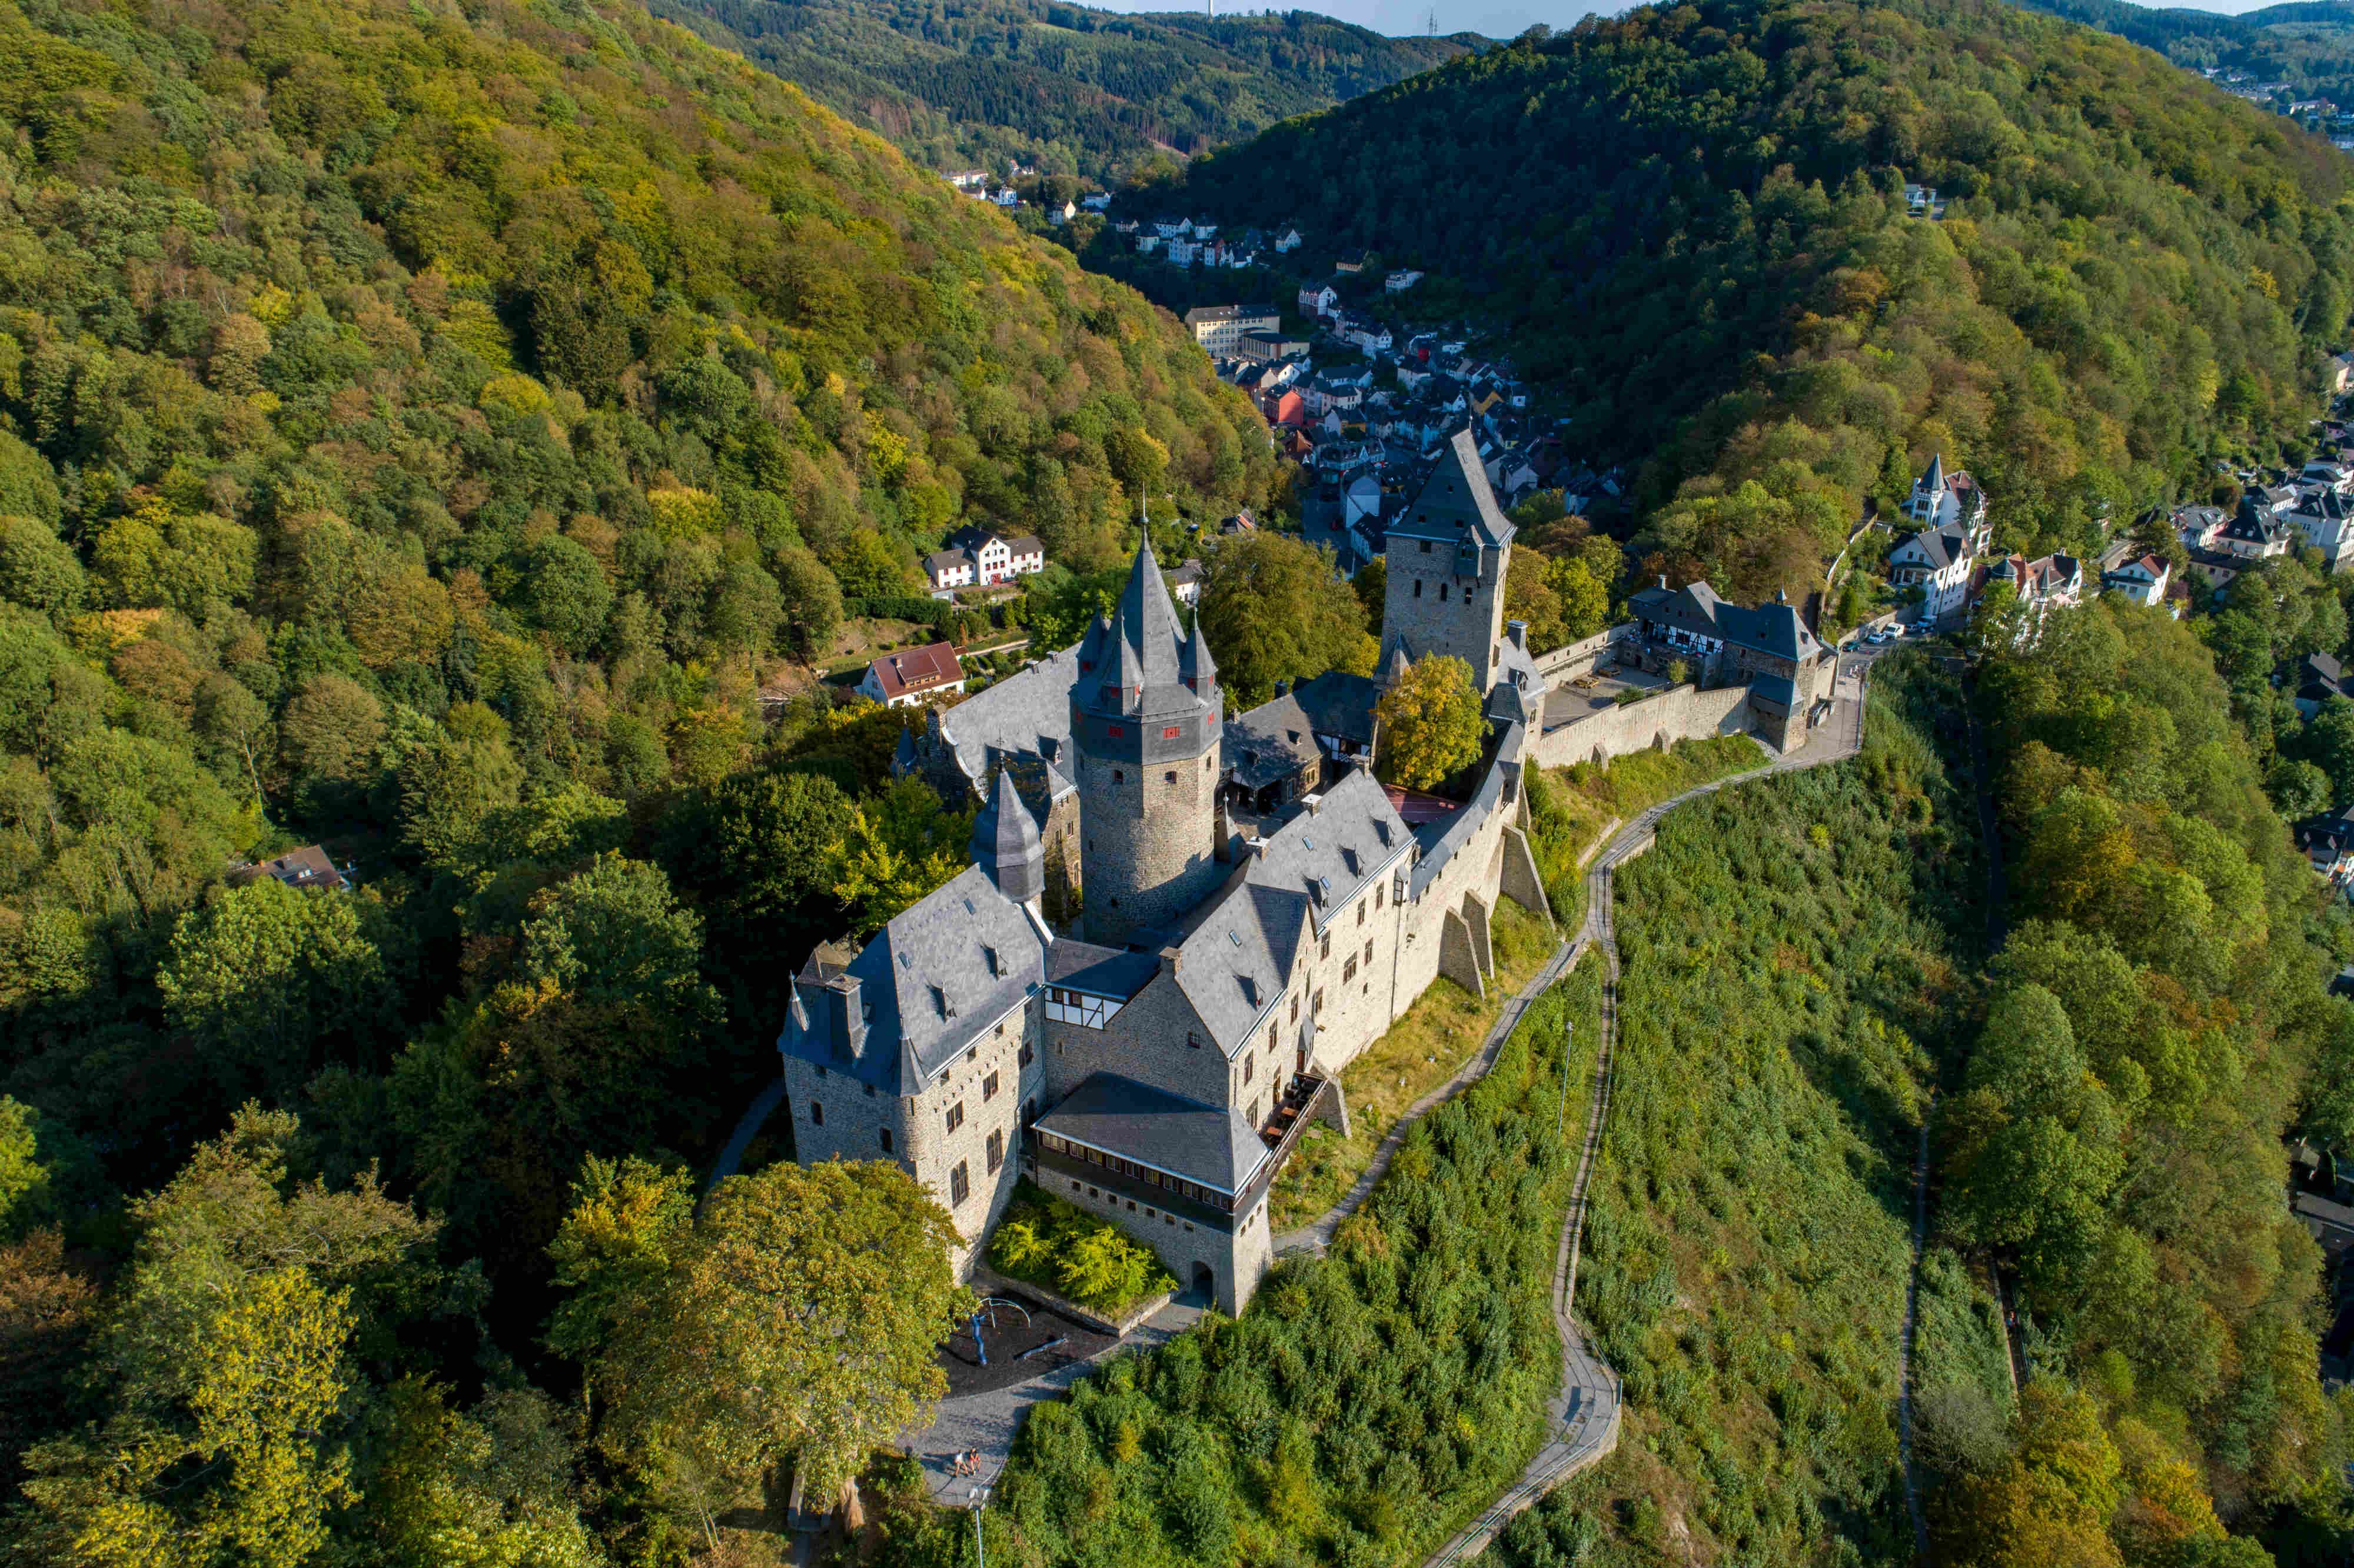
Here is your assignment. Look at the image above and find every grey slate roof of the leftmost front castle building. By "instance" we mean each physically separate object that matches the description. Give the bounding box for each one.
[777,867,1048,1095]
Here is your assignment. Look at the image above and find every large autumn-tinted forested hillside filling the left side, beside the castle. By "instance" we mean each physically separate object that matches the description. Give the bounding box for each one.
[0,0,1276,1568]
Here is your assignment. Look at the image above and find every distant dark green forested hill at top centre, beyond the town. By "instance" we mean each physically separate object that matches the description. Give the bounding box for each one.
[652,0,1485,179]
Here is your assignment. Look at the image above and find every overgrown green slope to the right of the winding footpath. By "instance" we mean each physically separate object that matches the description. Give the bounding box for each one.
[1499,659,1980,1563]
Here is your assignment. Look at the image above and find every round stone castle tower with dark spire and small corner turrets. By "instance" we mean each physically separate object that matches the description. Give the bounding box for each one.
[1071,544,1226,947]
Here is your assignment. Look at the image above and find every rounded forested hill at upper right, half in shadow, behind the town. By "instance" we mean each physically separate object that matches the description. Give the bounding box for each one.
[1153,0,2354,598]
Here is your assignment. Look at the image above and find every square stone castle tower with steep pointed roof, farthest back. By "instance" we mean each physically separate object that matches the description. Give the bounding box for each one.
[1382,431,1514,692]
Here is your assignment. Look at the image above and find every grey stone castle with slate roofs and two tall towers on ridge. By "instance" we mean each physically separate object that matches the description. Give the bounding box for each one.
[777,424,1820,1311]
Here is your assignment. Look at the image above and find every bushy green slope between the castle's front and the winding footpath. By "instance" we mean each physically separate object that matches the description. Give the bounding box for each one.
[984,963,1601,1568]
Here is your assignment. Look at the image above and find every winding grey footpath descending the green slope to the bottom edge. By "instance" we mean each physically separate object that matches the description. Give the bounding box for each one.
[1412,654,1874,1568]
